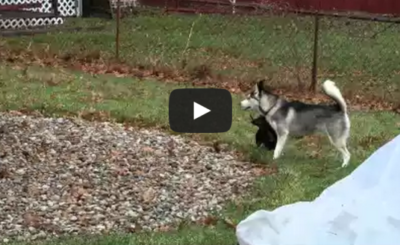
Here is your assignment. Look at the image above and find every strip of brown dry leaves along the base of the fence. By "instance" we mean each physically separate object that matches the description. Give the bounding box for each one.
[0,50,400,112]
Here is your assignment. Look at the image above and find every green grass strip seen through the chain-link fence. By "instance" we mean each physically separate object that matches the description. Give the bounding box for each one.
[0,14,400,102]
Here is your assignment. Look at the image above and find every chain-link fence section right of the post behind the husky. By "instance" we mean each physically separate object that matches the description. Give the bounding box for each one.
[318,17,400,102]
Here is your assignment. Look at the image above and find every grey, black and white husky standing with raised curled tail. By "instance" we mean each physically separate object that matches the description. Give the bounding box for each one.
[240,80,350,167]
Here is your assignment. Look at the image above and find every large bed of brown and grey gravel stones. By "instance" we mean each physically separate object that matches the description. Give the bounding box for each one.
[0,114,253,243]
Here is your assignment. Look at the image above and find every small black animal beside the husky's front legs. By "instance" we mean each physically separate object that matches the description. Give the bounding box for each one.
[250,115,277,151]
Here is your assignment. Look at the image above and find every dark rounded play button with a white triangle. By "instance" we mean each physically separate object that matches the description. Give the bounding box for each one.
[169,88,232,133]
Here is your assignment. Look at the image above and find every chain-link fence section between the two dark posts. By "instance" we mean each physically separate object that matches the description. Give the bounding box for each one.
[120,10,313,80]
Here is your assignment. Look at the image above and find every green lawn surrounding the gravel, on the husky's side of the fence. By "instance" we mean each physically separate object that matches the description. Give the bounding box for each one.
[0,64,400,245]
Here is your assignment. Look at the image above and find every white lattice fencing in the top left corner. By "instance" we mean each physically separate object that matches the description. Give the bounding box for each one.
[0,0,80,29]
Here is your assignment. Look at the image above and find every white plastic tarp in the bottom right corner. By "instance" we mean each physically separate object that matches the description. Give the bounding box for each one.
[236,135,400,245]
